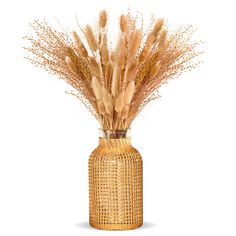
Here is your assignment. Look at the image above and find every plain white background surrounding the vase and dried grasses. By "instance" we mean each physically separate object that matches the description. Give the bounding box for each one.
[0,0,236,236]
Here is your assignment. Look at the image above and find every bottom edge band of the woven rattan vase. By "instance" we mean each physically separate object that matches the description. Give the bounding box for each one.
[89,222,143,230]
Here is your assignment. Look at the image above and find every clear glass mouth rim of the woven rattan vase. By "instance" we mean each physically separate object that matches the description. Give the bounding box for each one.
[99,128,130,139]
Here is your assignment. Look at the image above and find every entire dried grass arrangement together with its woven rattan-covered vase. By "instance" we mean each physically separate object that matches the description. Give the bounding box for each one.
[25,11,200,230]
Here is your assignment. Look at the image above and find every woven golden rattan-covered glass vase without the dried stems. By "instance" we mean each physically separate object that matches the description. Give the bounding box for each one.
[88,130,143,230]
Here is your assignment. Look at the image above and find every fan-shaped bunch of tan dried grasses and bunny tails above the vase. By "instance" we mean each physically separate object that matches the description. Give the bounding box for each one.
[24,11,200,130]
